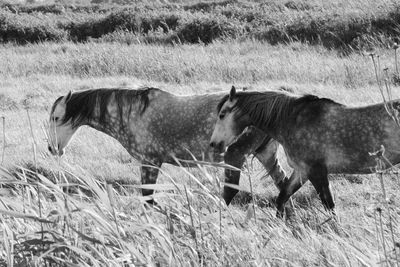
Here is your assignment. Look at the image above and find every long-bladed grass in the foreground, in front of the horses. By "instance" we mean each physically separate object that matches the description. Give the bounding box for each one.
[0,158,390,266]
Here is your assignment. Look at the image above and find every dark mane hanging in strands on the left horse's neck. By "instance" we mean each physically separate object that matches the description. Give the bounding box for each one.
[51,87,160,127]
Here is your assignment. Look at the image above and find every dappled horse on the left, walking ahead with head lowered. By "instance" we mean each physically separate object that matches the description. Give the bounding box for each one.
[48,88,285,204]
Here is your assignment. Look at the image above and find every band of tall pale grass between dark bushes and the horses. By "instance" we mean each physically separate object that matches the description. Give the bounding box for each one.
[0,41,393,91]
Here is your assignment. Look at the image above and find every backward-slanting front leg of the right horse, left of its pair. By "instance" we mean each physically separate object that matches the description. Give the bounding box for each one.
[276,170,303,218]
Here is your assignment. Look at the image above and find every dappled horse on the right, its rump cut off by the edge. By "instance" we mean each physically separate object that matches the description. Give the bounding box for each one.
[211,87,400,215]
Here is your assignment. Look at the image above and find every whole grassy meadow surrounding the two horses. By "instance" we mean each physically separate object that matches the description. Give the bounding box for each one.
[0,1,400,266]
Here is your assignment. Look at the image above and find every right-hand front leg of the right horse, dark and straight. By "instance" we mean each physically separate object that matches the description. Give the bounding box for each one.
[308,163,335,211]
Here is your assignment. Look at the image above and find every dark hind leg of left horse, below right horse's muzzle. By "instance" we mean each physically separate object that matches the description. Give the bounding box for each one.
[223,127,265,205]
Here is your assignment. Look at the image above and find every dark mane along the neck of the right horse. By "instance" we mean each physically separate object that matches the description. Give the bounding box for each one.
[217,91,341,129]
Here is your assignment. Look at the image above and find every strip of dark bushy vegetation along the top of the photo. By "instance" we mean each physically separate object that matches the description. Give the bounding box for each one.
[0,0,400,49]
